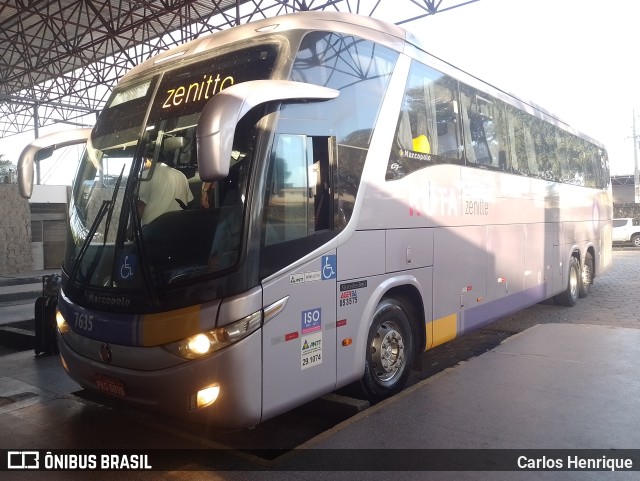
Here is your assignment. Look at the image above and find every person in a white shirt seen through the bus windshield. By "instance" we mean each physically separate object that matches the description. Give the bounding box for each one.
[137,156,193,227]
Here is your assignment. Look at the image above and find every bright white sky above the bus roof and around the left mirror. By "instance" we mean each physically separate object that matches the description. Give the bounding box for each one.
[0,0,640,184]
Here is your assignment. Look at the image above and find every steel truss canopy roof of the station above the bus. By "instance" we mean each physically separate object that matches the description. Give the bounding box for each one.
[0,0,478,138]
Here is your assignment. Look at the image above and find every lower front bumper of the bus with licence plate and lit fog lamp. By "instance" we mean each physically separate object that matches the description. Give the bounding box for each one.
[58,329,262,429]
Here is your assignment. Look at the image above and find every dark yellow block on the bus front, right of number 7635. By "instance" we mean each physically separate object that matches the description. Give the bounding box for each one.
[139,304,202,346]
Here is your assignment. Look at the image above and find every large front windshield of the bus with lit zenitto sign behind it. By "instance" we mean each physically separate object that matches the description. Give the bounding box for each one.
[65,43,279,292]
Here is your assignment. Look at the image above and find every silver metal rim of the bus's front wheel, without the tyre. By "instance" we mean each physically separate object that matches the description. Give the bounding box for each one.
[371,322,405,382]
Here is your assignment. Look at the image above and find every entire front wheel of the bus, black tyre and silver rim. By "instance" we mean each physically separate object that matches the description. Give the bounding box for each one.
[361,299,413,402]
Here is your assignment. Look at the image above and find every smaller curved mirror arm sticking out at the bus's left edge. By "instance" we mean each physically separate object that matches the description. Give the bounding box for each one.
[18,129,91,199]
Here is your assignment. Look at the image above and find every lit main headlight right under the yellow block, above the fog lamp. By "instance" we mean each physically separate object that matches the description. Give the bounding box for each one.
[165,311,262,359]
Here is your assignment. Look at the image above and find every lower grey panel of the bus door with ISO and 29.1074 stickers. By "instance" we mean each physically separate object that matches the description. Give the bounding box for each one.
[262,250,337,418]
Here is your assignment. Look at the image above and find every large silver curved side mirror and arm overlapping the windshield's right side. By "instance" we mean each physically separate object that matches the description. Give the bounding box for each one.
[196,80,340,182]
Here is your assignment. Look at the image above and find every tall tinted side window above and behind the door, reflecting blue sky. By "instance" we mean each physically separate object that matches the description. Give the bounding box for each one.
[282,32,398,223]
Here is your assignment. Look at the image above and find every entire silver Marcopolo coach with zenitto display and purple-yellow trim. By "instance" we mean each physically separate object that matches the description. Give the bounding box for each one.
[19,12,612,428]
